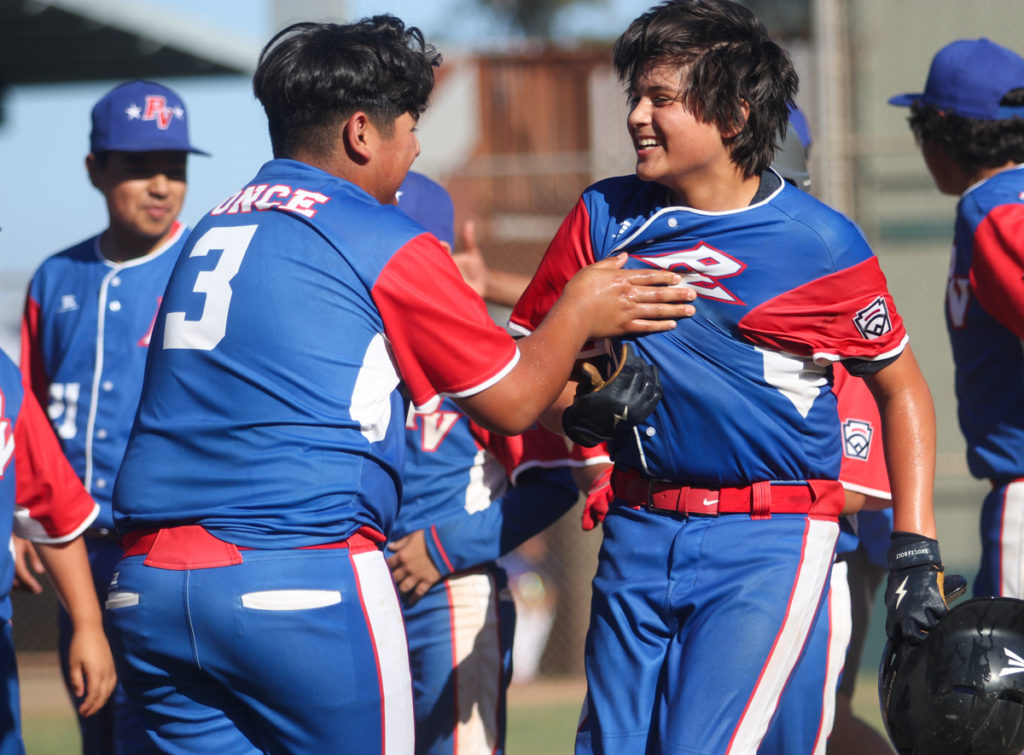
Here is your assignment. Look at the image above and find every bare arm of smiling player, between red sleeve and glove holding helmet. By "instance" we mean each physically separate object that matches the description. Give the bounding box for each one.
[868,347,936,538]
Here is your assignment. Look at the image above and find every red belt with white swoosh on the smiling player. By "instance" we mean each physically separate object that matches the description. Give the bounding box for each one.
[611,466,845,519]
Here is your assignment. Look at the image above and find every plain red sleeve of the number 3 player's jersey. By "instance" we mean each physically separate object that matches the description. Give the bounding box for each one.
[373,234,518,409]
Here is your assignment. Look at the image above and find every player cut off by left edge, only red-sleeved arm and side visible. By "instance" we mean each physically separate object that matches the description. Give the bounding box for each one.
[0,353,117,755]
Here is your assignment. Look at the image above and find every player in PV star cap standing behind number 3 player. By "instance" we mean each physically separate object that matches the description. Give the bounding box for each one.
[20,80,206,755]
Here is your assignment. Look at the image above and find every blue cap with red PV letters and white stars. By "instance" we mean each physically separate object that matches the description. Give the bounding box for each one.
[89,79,209,155]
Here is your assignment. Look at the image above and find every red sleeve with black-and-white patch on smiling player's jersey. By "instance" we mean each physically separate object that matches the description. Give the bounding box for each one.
[739,257,906,362]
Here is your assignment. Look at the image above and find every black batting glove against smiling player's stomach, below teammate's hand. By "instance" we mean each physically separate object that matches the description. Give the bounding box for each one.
[562,343,662,448]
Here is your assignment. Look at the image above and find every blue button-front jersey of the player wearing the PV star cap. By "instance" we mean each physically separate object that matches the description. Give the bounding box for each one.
[22,222,187,529]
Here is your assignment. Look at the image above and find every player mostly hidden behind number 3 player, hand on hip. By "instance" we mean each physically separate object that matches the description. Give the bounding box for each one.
[388,171,579,755]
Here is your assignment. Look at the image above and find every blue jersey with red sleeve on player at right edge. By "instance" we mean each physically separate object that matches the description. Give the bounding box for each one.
[946,166,1024,479]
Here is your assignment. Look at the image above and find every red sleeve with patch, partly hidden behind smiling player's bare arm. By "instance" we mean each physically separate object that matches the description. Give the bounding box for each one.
[833,365,892,499]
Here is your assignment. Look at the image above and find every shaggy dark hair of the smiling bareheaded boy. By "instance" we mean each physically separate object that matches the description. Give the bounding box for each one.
[613,0,799,177]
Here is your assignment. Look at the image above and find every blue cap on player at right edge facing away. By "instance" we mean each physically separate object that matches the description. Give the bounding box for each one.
[889,37,1024,121]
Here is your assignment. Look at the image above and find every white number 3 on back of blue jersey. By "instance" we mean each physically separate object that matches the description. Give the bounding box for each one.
[164,225,256,351]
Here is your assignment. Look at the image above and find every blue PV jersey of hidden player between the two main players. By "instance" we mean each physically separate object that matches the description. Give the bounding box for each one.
[391,400,579,575]
